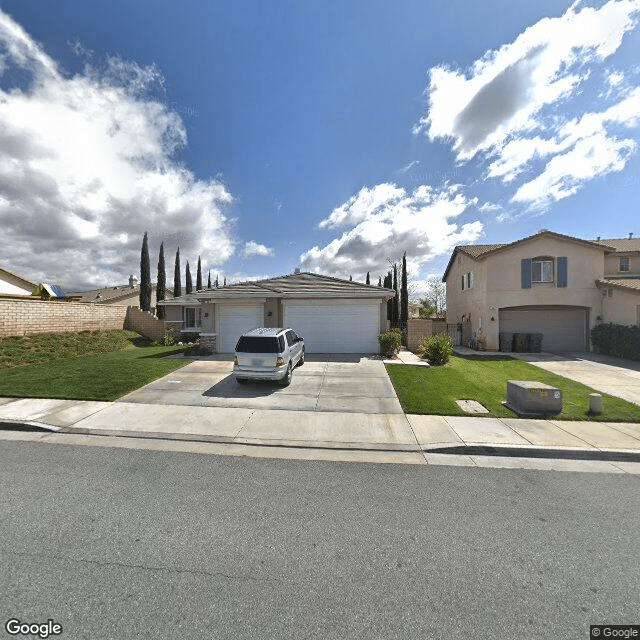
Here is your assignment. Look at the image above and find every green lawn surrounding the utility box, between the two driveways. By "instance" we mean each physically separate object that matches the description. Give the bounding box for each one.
[387,356,640,422]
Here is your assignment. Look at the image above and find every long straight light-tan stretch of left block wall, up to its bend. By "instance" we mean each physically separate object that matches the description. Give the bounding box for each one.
[0,298,127,336]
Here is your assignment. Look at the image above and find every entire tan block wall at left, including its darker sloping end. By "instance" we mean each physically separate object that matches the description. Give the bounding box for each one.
[0,298,165,340]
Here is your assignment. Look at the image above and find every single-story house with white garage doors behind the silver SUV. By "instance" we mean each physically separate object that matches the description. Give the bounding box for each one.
[159,272,394,353]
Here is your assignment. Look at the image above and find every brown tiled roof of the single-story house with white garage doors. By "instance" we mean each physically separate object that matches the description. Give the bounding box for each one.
[160,272,395,305]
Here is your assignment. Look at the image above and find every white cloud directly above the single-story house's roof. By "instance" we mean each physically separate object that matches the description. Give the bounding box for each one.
[300,184,483,280]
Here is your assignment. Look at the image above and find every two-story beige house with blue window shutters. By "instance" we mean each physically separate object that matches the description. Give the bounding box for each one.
[443,230,640,351]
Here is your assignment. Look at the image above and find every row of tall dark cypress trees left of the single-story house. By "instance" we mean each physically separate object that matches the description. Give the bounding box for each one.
[140,231,227,319]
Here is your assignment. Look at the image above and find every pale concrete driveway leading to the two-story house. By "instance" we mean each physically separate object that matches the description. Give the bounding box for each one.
[511,352,640,405]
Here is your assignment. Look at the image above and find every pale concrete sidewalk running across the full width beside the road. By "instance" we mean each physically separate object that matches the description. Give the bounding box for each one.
[0,398,640,464]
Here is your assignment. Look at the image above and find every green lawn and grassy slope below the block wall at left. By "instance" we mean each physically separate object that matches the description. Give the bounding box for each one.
[0,331,188,400]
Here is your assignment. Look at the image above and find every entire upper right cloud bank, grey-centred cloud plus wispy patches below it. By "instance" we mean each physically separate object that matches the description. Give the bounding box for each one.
[415,0,640,207]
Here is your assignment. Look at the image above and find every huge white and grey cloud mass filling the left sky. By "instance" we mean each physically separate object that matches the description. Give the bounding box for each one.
[0,11,234,288]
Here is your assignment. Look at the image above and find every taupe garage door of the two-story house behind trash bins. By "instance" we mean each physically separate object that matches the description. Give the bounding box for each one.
[500,306,588,351]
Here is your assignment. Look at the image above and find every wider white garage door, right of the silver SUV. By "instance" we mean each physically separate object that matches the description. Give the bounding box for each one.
[284,300,380,353]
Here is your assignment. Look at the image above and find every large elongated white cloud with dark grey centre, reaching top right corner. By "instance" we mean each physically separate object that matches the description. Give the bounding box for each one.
[416,0,640,161]
